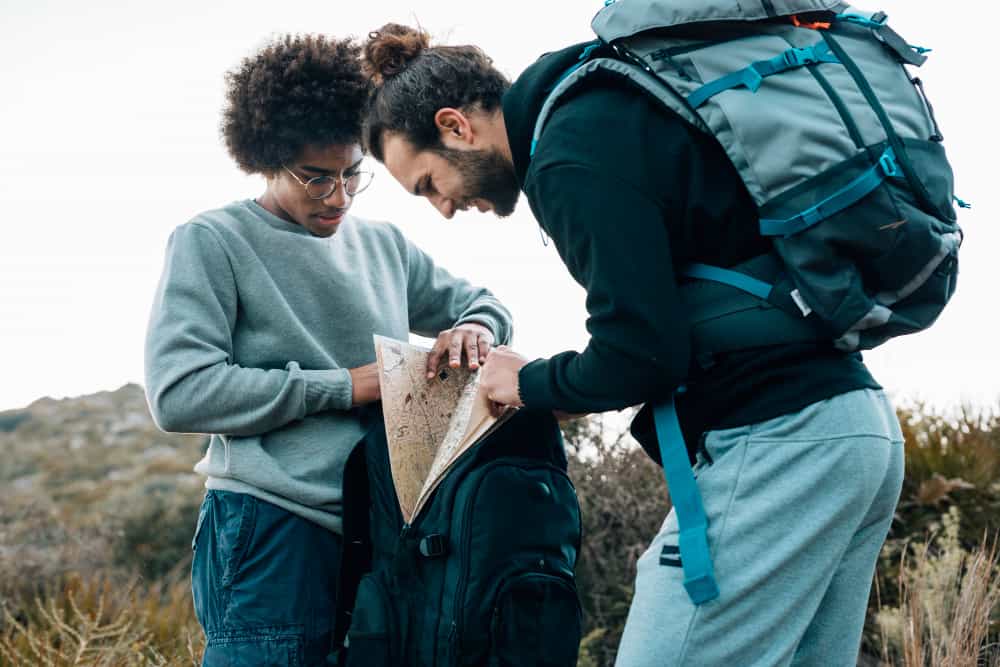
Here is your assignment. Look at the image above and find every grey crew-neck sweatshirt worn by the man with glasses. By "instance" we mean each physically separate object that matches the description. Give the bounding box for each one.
[145,200,511,532]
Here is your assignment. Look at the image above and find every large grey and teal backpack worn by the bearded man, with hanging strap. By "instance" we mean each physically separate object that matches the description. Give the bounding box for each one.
[532,0,966,604]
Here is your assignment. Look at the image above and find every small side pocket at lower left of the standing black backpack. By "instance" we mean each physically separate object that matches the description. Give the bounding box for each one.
[347,573,404,667]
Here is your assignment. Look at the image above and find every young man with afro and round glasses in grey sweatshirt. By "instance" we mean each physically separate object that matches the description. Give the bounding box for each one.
[145,35,511,665]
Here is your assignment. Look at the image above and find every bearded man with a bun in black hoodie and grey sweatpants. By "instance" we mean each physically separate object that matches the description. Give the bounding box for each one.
[364,24,903,667]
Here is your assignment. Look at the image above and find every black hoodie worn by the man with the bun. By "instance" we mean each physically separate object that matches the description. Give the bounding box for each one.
[503,44,879,458]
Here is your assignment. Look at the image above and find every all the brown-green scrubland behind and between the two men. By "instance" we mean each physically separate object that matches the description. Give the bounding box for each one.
[0,385,1000,667]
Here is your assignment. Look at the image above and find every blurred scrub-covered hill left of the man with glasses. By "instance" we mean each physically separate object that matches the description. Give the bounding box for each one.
[0,384,206,597]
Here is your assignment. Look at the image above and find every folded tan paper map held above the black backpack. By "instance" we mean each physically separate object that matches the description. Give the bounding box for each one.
[375,336,513,523]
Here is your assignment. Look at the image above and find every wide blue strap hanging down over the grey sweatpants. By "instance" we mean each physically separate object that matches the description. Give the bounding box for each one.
[653,389,719,605]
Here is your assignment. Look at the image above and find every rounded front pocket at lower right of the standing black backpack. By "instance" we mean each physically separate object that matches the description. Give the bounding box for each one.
[488,573,581,667]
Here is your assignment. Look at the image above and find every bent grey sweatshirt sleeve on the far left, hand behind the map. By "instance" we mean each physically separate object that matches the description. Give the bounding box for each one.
[145,223,352,436]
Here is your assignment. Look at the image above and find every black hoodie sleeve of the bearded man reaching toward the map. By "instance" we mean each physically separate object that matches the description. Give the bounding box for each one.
[519,162,690,413]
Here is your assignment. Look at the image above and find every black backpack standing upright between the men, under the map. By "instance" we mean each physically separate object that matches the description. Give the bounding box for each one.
[334,410,581,667]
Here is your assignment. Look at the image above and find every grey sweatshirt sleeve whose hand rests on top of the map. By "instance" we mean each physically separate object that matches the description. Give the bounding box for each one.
[400,235,512,345]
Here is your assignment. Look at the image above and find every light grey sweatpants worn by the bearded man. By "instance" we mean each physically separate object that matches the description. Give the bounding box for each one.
[615,389,903,667]
